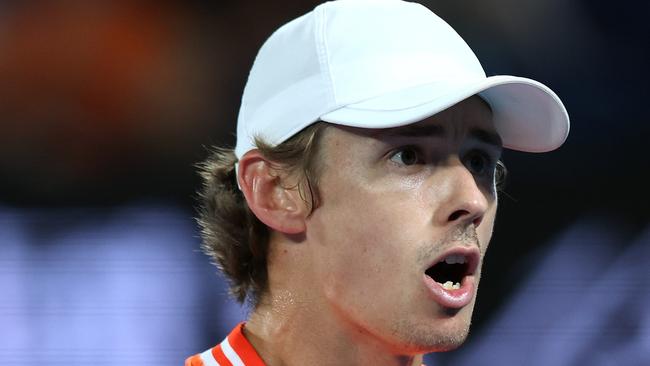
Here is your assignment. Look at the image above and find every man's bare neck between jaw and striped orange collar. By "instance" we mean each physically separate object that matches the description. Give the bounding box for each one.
[244,291,422,366]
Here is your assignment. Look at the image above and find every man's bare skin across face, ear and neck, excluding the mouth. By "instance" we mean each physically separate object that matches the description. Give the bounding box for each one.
[240,96,501,365]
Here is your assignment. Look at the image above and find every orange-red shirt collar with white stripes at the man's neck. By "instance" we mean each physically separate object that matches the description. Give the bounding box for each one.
[185,323,265,366]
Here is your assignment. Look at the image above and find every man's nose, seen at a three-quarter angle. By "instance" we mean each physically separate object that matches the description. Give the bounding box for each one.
[434,161,490,227]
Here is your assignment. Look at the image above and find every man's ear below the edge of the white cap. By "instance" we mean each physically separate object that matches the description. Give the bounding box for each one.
[237,150,308,234]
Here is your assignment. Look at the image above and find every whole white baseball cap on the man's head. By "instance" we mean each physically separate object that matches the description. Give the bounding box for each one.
[235,0,569,158]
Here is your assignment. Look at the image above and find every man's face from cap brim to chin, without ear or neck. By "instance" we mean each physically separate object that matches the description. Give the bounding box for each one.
[306,96,501,353]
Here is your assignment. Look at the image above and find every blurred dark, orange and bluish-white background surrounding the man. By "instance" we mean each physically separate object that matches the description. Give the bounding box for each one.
[0,0,650,365]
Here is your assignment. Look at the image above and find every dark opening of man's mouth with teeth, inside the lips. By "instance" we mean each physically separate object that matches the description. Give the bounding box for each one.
[425,253,476,290]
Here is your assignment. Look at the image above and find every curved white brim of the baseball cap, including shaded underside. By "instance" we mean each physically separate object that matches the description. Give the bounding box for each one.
[320,75,569,152]
